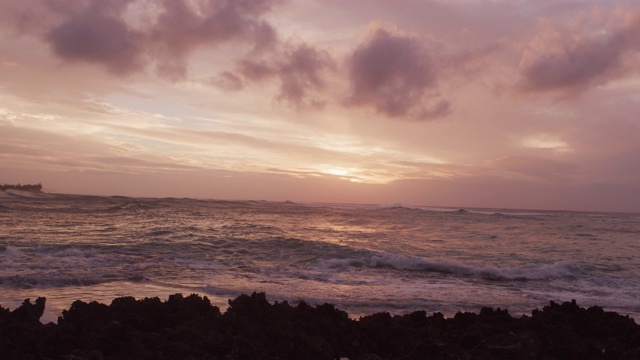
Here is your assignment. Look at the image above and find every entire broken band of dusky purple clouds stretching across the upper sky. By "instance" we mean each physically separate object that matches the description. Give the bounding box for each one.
[5,0,640,108]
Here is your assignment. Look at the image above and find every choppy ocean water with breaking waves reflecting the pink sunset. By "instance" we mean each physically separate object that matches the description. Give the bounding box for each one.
[0,190,640,322]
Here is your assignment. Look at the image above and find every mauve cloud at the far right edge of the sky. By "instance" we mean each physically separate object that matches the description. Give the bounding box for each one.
[520,8,640,93]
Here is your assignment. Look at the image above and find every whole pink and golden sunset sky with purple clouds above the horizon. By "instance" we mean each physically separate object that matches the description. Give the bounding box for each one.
[0,0,640,212]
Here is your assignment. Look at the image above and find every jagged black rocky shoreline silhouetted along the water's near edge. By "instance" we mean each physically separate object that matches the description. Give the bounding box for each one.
[0,293,640,360]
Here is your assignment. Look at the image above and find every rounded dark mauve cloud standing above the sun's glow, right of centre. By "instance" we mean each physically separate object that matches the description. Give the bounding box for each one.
[345,27,450,120]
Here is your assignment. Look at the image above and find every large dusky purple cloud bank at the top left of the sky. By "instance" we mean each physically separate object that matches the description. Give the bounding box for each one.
[33,0,280,80]
